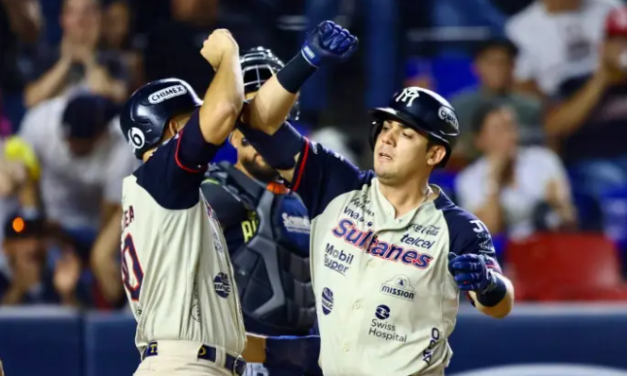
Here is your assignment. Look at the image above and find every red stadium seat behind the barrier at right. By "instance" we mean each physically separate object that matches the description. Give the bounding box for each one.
[505,234,627,301]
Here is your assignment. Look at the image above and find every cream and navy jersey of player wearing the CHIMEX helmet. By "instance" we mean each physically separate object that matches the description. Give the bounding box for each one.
[122,134,246,354]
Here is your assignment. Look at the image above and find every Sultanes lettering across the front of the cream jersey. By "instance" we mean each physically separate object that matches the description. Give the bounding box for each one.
[331,219,433,269]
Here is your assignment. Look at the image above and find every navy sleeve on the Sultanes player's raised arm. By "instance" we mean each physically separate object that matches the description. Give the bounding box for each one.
[292,139,374,220]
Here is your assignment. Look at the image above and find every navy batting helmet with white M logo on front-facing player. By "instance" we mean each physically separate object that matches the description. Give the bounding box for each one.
[370,86,459,167]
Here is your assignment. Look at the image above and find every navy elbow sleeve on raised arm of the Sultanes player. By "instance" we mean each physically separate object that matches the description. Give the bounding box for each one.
[238,122,305,170]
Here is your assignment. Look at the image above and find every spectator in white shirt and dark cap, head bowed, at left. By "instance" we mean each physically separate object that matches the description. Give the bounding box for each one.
[15,93,137,257]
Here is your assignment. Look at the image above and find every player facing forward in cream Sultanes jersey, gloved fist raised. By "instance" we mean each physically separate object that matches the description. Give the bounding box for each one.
[239,23,514,376]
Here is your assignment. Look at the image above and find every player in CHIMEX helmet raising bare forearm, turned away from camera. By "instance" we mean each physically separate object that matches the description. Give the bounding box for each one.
[121,29,246,376]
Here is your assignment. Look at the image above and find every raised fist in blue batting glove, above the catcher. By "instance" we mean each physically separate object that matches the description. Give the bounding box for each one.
[301,21,359,67]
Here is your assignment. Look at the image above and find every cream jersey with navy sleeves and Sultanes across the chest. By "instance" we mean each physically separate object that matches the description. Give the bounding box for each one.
[293,141,499,376]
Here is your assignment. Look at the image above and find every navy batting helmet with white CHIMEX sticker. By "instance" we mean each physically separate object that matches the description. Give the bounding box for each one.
[120,78,202,159]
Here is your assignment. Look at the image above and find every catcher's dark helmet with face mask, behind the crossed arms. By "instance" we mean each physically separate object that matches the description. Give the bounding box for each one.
[240,47,300,120]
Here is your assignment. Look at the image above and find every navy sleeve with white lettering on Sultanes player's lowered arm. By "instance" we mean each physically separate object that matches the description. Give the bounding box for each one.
[444,207,501,273]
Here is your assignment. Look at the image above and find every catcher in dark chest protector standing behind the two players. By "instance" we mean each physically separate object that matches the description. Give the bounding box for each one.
[202,47,319,376]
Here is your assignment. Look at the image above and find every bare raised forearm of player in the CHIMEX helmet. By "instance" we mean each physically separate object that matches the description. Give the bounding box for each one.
[200,54,244,145]
